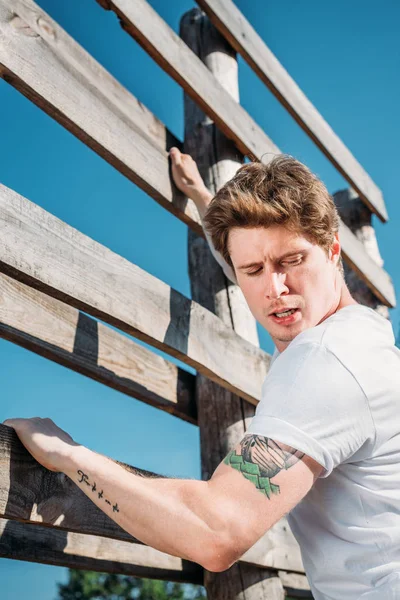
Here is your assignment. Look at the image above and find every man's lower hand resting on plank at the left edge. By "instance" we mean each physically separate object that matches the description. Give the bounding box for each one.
[3,417,79,472]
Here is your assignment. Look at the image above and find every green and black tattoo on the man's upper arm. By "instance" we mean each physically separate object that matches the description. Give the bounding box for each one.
[224,434,304,498]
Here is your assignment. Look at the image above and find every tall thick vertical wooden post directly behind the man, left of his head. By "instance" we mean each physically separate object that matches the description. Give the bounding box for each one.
[181,9,285,600]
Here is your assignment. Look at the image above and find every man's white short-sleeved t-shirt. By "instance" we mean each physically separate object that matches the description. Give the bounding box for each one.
[248,305,400,600]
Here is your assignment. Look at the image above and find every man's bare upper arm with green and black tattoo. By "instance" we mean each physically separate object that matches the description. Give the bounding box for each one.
[209,434,323,562]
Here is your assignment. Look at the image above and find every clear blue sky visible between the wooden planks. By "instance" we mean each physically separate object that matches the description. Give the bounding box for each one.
[0,0,400,600]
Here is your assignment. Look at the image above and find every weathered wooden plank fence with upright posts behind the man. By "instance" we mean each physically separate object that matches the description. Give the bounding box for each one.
[0,0,395,600]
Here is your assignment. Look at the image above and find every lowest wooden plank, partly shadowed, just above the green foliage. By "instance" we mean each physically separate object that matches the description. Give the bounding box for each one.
[0,519,203,585]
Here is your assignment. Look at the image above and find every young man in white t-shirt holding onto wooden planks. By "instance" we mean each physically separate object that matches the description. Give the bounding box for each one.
[5,149,400,600]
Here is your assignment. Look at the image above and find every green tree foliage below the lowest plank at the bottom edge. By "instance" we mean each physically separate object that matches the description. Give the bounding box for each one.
[56,569,206,600]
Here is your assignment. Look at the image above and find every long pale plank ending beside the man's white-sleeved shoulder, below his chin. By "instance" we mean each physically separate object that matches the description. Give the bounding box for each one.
[0,186,270,404]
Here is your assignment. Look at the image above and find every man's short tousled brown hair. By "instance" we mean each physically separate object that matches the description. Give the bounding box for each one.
[204,154,339,266]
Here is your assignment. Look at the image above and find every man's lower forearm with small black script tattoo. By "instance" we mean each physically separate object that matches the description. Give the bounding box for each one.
[63,446,231,570]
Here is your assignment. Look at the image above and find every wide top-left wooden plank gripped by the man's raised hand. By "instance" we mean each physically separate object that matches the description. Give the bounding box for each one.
[0,0,202,233]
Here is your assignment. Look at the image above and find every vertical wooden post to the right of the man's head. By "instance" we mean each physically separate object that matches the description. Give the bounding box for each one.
[333,188,389,319]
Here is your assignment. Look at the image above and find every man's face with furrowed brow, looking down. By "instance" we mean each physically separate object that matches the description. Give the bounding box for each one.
[229,225,341,352]
